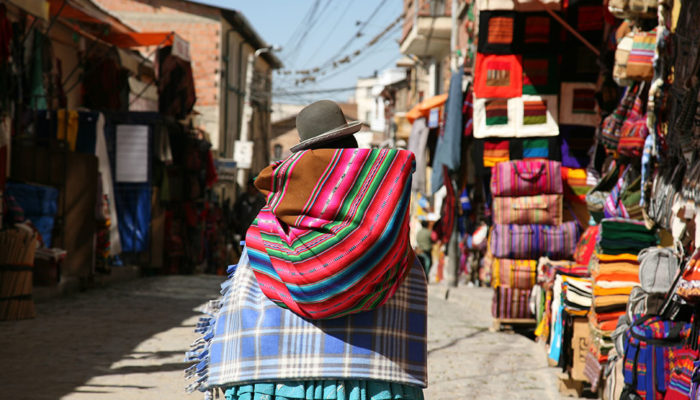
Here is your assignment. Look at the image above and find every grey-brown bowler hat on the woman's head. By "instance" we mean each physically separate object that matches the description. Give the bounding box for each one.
[291,100,362,152]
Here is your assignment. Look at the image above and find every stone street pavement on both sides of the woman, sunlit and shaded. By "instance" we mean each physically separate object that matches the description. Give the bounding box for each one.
[0,276,580,400]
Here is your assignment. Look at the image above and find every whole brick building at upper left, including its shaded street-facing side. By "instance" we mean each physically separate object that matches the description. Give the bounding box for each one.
[96,0,282,182]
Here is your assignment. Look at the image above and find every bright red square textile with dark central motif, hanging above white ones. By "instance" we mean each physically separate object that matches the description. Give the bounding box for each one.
[474,53,523,98]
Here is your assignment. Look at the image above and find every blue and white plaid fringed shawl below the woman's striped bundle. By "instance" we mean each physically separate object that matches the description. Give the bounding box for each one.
[186,251,427,391]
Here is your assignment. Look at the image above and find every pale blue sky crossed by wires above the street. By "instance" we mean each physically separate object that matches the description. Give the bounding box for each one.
[190,0,403,104]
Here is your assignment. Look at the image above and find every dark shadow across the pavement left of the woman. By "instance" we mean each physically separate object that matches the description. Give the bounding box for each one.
[0,276,222,399]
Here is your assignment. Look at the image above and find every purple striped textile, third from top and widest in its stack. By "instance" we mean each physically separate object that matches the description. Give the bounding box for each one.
[490,221,578,260]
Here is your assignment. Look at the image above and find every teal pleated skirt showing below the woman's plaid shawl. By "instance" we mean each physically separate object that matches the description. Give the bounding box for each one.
[225,380,423,400]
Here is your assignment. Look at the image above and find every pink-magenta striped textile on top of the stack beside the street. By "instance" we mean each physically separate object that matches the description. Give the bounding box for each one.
[491,160,564,196]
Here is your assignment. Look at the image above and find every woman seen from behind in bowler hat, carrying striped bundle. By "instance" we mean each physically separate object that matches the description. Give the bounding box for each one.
[188,100,427,400]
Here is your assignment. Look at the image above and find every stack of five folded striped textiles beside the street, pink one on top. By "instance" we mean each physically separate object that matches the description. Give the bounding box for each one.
[490,159,578,319]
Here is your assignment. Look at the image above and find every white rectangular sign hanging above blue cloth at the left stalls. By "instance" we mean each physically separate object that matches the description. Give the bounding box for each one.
[116,125,148,183]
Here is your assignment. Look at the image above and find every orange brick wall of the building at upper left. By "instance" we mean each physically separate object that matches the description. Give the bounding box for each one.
[96,0,221,107]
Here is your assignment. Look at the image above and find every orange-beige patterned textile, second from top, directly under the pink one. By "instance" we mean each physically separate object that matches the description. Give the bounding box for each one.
[493,194,563,225]
